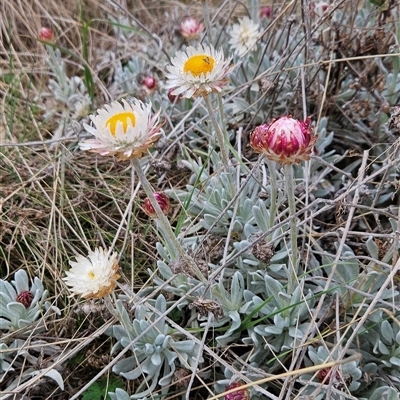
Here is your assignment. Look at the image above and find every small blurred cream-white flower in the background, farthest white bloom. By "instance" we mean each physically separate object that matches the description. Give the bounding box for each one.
[229,17,260,57]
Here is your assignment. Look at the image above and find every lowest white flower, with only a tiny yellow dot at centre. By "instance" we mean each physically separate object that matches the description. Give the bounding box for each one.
[63,248,120,299]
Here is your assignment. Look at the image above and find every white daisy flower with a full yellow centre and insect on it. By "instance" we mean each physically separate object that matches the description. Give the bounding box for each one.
[166,45,232,98]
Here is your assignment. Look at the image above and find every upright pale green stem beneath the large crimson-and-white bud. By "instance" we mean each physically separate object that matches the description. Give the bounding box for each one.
[285,164,299,294]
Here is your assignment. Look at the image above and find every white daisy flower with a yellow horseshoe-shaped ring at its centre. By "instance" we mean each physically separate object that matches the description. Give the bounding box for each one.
[79,99,161,160]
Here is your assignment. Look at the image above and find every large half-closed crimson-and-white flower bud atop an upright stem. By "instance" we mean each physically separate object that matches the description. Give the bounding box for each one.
[250,116,317,164]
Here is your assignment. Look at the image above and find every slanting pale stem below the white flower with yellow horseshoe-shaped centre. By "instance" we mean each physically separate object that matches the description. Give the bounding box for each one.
[132,158,207,283]
